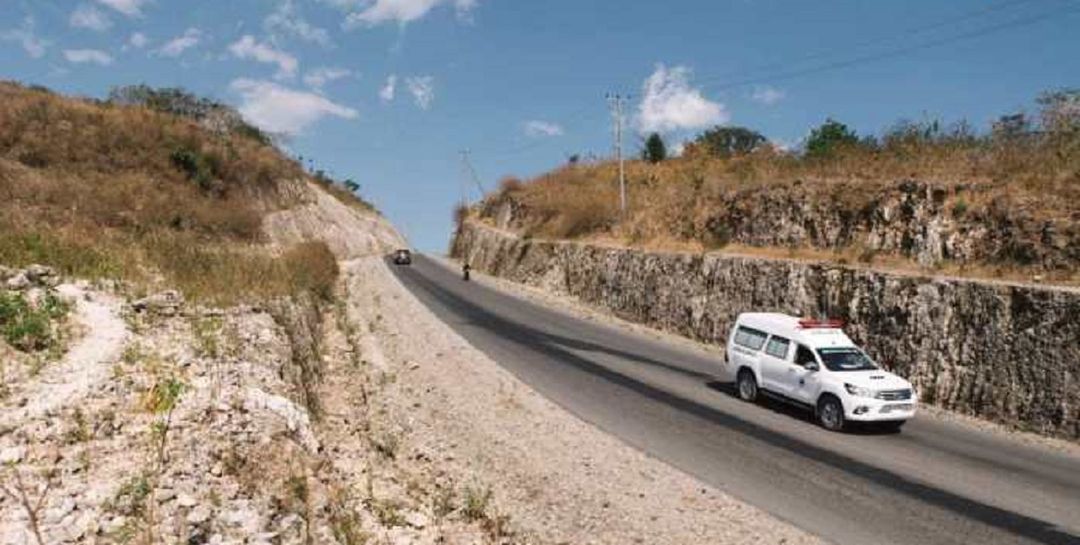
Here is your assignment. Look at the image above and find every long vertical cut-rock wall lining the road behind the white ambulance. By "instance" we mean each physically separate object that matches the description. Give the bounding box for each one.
[451,222,1080,439]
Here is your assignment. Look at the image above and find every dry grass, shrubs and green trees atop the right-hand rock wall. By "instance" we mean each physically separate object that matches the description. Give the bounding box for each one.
[477,91,1080,280]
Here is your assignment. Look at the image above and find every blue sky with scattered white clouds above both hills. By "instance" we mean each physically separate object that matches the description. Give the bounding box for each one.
[0,0,1080,251]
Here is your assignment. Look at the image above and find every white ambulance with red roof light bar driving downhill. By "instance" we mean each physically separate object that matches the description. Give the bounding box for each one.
[726,313,917,431]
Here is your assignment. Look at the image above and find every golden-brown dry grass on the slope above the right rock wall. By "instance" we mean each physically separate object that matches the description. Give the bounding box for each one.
[478,112,1080,273]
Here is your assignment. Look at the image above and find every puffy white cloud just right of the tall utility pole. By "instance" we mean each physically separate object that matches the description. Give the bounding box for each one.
[637,65,731,133]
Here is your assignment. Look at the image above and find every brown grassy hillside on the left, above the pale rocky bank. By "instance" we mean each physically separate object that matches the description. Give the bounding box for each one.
[0,83,369,304]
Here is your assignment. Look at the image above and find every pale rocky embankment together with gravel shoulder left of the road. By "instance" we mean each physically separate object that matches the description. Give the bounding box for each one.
[0,175,818,545]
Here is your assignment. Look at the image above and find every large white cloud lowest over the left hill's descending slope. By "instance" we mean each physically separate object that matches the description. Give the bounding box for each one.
[229,79,360,136]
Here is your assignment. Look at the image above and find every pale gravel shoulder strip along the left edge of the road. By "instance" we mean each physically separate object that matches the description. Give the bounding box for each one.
[347,259,819,544]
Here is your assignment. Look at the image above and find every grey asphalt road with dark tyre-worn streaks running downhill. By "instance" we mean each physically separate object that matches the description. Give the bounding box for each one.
[394,256,1080,545]
